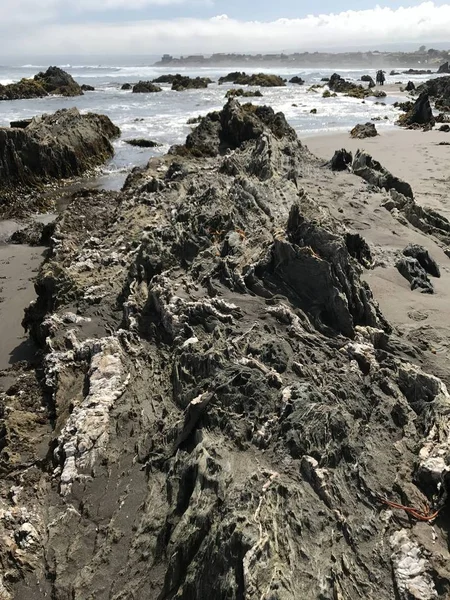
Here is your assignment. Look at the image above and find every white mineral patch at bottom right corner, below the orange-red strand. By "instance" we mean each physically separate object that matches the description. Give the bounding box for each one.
[390,529,438,600]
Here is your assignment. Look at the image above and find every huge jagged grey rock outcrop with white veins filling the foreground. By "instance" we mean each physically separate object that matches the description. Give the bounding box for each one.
[0,101,450,600]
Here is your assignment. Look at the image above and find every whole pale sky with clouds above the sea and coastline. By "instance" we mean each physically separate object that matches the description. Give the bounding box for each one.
[0,0,450,56]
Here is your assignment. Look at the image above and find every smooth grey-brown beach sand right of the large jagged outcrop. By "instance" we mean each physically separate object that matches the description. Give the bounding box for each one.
[306,129,450,384]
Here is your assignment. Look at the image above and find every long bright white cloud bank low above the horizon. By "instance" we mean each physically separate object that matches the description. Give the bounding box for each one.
[0,0,450,55]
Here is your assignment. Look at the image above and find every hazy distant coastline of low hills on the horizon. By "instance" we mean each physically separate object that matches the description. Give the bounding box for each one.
[153,48,450,69]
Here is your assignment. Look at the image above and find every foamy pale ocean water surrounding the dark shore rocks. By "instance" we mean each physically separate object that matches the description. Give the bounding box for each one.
[0,64,436,188]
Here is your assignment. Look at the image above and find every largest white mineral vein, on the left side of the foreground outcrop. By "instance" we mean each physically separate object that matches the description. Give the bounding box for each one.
[56,338,130,496]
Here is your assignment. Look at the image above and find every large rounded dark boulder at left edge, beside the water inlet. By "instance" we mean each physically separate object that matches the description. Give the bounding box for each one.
[0,108,120,198]
